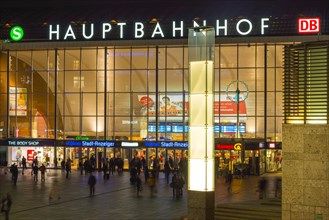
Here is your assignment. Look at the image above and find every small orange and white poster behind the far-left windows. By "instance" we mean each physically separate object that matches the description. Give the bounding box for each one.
[9,87,27,116]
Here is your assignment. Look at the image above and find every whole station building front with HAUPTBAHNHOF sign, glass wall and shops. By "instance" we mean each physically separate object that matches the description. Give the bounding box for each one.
[0,1,329,175]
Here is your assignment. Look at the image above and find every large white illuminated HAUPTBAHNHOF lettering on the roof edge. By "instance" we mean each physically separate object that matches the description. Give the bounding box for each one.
[48,17,270,41]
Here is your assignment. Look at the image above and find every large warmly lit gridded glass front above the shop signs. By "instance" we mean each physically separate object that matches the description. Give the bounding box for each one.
[0,44,283,141]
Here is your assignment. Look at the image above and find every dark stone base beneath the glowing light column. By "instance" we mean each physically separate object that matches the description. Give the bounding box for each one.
[188,190,215,220]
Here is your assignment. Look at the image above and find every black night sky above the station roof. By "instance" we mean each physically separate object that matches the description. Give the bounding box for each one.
[0,0,329,25]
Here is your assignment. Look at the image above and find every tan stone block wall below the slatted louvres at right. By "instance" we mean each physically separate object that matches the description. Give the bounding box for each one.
[282,124,329,220]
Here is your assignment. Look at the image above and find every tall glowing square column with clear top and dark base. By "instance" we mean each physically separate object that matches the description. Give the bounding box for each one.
[188,27,215,219]
